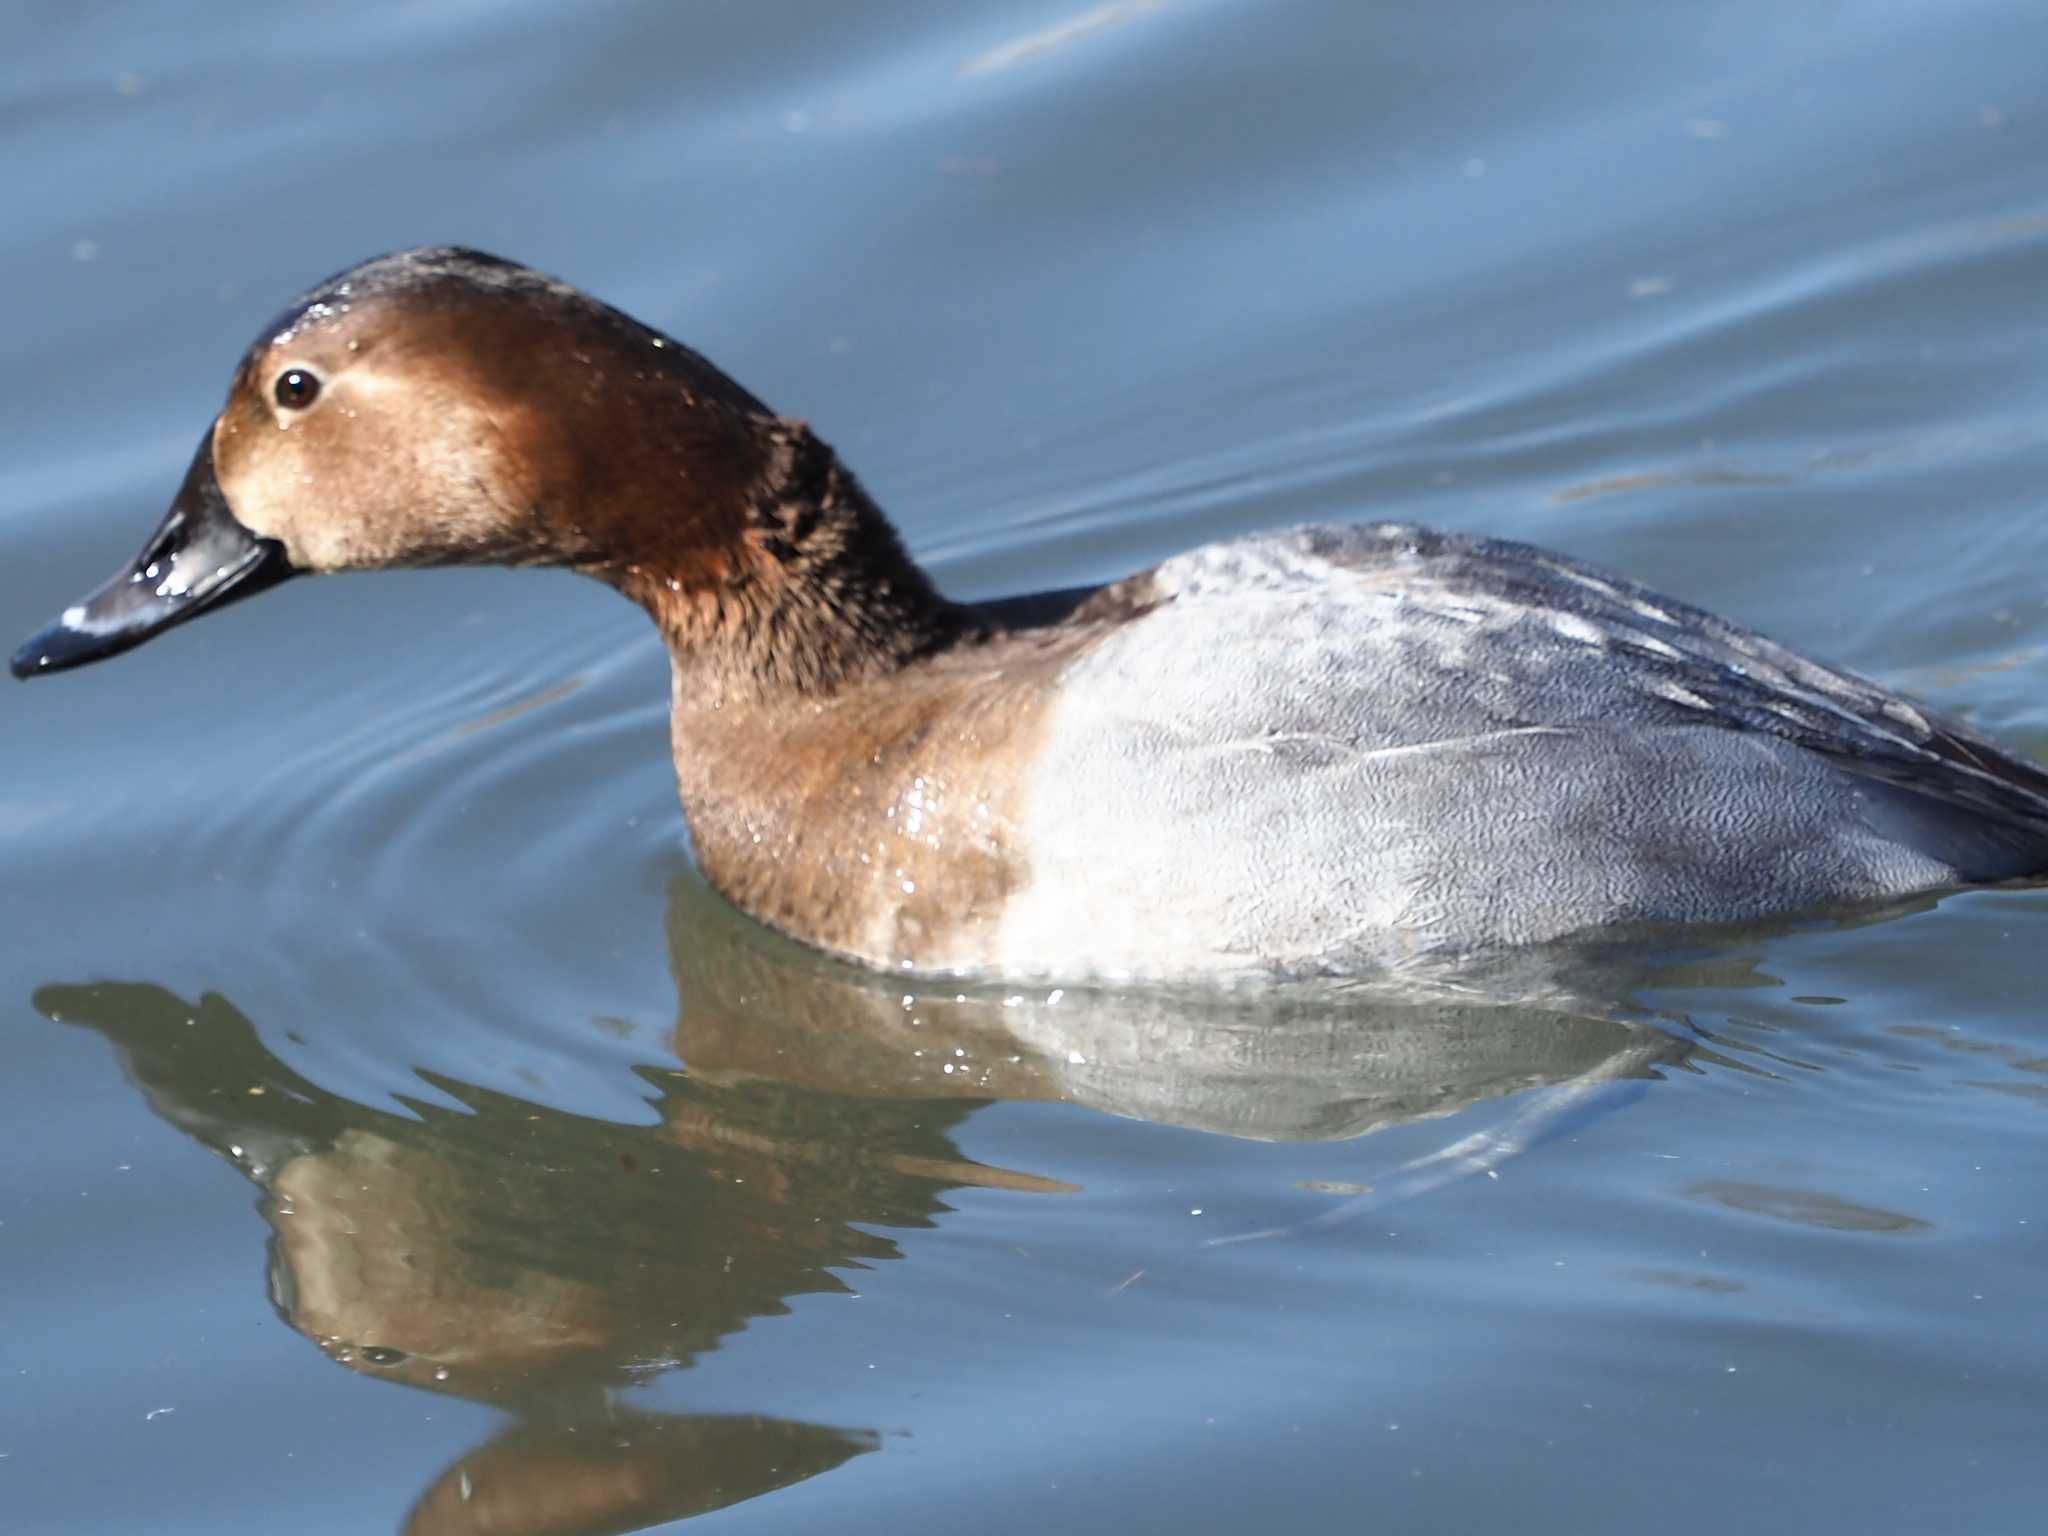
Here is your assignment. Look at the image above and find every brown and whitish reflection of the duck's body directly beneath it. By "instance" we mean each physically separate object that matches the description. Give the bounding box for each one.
[670,881,1695,1141]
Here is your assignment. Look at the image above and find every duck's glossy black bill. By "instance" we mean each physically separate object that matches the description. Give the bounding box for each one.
[8,432,291,678]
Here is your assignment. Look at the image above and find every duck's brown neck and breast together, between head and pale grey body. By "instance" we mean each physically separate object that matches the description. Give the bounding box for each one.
[618,422,1038,969]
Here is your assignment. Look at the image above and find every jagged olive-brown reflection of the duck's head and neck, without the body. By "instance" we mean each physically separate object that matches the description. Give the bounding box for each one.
[37,985,892,1536]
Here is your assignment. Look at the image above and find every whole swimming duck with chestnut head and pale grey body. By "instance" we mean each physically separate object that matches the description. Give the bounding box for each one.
[12,246,2048,985]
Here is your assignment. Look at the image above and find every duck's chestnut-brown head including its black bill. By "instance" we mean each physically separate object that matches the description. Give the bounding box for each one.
[12,248,788,678]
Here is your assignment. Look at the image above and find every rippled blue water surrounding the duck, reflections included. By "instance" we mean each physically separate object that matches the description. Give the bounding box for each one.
[0,0,2048,1532]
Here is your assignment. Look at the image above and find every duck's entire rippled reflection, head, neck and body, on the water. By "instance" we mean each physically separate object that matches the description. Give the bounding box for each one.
[37,883,1686,1536]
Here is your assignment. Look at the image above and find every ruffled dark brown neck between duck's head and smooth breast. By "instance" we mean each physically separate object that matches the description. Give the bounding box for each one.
[616,420,983,711]
